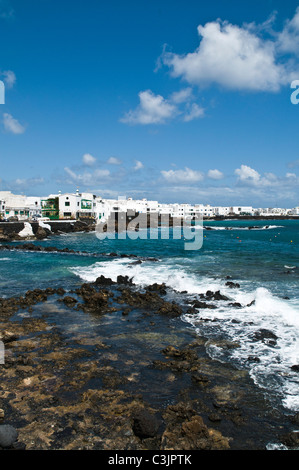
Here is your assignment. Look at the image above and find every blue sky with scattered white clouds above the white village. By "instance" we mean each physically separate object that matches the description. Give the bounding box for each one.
[0,0,299,208]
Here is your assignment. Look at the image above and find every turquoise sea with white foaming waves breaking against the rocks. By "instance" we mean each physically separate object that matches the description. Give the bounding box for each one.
[0,220,299,412]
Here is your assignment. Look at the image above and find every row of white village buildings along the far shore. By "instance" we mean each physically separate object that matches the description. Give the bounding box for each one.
[0,189,299,222]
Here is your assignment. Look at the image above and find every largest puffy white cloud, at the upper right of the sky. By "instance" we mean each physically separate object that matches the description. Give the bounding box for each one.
[163,14,299,92]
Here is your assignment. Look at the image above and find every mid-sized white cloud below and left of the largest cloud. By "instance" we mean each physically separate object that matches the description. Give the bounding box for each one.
[121,90,177,124]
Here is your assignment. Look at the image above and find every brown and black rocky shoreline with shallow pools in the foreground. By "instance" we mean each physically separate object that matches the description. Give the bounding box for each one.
[0,276,299,451]
